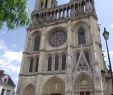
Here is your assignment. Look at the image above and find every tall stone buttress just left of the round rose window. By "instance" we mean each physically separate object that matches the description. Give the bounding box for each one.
[35,27,47,95]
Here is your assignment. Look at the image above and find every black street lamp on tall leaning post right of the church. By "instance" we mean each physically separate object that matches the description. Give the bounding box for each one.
[103,28,113,95]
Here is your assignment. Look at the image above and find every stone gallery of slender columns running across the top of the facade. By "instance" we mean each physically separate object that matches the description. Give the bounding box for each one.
[29,0,97,28]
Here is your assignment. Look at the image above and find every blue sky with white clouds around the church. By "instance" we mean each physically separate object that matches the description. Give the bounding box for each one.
[0,0,113,87]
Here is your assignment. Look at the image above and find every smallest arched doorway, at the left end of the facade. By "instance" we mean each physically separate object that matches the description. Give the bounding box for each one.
[23,84,35,95]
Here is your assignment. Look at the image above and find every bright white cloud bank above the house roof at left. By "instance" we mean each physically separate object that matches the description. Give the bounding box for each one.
[0,40,22,75]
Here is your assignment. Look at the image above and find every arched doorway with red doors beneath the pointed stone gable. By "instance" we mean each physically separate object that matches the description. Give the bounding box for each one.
[74,73,94,95]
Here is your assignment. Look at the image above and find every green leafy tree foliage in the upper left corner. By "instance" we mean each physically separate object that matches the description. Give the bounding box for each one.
[0,0,29,29]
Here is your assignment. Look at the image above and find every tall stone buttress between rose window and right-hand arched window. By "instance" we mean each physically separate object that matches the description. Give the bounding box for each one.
[65,21,73,95]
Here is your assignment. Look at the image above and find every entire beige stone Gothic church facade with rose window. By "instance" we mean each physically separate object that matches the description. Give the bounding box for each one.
[17,0,111,95]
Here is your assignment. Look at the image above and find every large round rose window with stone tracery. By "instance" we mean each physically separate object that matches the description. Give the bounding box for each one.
[48,30,67,47]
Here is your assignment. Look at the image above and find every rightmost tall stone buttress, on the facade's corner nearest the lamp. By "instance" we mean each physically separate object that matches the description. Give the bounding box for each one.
[90,17,103,95]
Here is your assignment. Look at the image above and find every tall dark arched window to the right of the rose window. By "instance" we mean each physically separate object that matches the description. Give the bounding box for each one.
[78,28,86,45]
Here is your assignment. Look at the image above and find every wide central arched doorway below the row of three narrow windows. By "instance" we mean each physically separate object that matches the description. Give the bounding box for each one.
[43,77,65,95]
